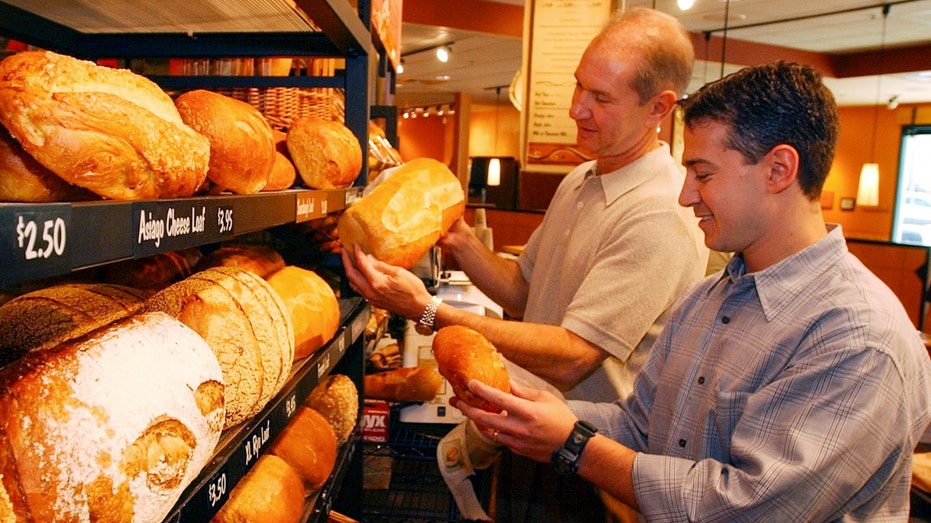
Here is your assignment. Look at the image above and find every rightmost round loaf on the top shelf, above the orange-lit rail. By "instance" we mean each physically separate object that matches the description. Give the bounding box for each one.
[287,116,362,189]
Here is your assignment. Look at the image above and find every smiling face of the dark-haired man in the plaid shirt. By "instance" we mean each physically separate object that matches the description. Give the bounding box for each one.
[679,121,767,252]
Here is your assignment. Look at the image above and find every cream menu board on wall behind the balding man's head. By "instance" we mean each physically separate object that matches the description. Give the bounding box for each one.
[524,0,611,171]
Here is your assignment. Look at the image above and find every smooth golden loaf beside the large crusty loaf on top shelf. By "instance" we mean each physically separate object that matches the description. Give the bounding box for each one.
[175,89,275,194]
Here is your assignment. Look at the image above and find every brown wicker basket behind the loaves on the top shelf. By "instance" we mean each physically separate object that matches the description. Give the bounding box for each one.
[217,87,345,131]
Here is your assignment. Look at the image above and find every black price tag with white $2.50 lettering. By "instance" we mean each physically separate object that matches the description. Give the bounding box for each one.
[0,204,71,286]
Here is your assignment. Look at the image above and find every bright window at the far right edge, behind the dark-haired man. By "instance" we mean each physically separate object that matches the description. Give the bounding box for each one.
[892,129,931,246]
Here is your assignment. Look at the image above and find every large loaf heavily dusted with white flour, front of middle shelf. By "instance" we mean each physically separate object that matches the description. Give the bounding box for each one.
[0,313,223,523]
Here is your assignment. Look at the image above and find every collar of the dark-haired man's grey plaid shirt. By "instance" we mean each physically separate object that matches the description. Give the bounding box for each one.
[722,224,847,321]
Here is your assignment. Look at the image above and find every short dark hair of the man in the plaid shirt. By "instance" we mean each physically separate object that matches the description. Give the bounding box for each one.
[681,61,840,199]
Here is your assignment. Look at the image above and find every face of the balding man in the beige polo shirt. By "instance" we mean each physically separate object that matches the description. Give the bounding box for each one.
[569,46,655,158]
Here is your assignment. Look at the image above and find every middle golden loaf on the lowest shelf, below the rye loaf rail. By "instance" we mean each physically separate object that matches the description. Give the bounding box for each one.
[268,406,336,496]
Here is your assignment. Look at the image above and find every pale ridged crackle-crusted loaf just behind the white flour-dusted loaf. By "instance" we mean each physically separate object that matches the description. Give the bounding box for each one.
[143,267,294,427]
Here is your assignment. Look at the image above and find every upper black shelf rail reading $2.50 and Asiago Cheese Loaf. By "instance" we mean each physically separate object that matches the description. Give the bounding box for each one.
[0,187,361,288]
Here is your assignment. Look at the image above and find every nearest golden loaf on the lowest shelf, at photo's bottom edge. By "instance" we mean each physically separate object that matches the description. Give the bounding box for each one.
[210,454,304,523]
